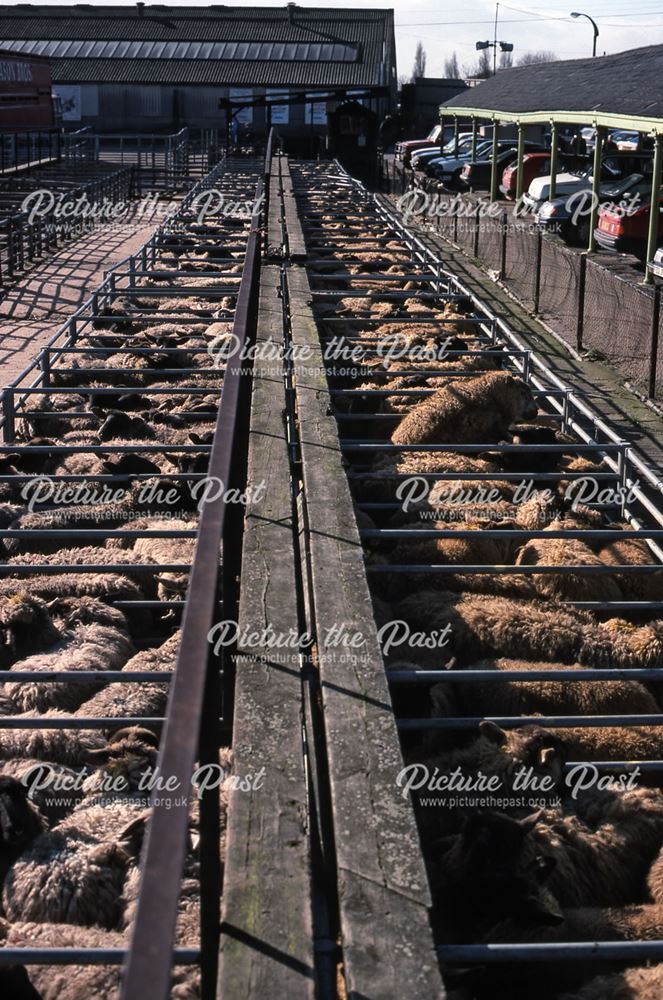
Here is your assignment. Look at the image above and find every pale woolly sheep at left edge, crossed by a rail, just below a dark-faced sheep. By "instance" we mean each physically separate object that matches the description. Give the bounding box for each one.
[0,598,133,713]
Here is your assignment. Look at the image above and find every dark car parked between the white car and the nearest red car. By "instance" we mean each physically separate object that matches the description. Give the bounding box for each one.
[536,174,651,246]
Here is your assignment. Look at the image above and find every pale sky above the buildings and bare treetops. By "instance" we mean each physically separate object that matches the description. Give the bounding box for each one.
[16,0,663,78]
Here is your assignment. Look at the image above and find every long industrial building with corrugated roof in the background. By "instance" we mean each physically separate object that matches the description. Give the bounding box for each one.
[0,3,397,143]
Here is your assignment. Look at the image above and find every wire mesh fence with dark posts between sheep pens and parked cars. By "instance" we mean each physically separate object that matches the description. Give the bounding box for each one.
[393,166,663,401]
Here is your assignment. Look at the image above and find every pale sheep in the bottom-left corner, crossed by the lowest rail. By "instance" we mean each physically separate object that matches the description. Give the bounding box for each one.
[0,921,200,1000]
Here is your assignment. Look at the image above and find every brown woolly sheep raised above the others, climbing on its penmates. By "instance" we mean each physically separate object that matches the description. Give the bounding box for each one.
[391,372,537,444]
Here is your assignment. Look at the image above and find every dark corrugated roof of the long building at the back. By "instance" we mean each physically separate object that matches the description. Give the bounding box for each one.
[0,4,395,87]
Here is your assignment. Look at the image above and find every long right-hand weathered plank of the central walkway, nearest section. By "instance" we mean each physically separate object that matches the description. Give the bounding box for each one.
[287,266,445,1000]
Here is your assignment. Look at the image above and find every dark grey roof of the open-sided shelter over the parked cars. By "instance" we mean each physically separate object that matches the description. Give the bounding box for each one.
[446,45,663,118]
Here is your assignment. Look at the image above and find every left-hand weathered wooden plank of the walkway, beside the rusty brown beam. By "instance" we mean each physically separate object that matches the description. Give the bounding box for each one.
[218,262,315,1000]
